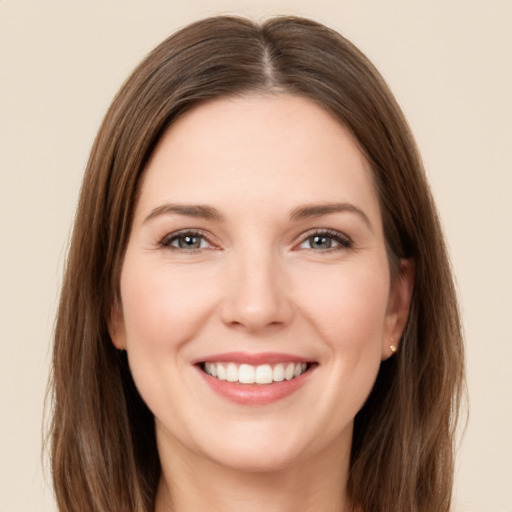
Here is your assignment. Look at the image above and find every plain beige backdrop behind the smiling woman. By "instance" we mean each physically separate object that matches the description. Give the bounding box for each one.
[0,0,512,512]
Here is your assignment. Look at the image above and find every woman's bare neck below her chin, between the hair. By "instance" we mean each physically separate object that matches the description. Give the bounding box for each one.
[155,432,350,512]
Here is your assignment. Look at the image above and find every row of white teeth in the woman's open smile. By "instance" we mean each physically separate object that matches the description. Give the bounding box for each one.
[204,363,307,384]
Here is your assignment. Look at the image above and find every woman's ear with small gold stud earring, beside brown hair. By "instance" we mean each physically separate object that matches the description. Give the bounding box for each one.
[382,259,415,361]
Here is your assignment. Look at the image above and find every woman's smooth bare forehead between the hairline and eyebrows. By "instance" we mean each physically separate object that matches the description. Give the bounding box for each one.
[134,94,380,227]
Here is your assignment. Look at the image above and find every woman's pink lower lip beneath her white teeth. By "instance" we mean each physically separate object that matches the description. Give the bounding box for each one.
[198,368,313,405]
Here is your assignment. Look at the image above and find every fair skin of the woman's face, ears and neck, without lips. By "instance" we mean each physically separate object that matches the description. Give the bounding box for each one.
[110,94,412,512]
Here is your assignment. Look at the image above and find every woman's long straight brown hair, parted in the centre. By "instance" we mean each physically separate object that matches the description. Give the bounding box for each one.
[51,16,463,512]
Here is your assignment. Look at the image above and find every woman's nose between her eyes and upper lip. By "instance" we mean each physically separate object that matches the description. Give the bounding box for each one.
[221,247,293,332]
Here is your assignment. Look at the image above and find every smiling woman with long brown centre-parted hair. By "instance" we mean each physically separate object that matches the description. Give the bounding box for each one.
[52,17,463,512]
